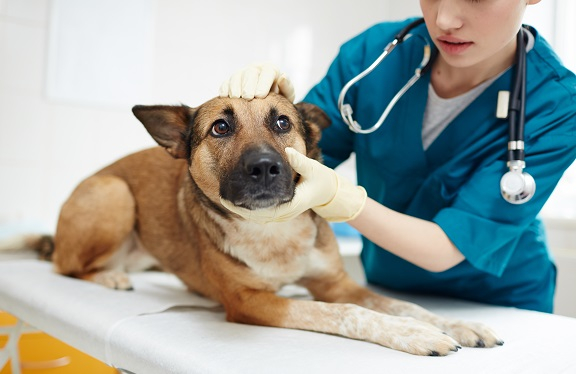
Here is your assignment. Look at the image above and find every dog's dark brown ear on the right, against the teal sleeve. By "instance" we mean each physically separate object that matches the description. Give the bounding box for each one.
[296,103,331,161]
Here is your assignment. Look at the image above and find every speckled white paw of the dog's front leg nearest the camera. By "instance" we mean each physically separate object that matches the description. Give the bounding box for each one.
[381,317,462,356]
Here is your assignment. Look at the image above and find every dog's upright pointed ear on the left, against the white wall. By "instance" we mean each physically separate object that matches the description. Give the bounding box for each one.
[132,105,194,158]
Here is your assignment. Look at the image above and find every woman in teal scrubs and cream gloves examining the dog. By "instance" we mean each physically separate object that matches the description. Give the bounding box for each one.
[220,0,576,312]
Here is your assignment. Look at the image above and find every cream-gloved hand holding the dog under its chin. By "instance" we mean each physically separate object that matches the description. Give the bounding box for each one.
[220,148,366,223]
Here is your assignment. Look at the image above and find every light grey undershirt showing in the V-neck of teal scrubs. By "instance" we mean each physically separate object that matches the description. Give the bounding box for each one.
[422,32,534,150]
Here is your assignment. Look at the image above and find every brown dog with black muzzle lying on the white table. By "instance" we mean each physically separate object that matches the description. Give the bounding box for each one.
[47,94,502,355]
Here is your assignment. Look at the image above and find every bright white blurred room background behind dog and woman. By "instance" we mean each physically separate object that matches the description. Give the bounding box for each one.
[0,0,576,316]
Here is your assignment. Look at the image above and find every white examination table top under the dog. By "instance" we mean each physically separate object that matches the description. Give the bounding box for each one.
[0,260,576,374]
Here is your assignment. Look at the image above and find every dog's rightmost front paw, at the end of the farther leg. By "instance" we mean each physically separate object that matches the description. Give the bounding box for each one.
[444,321,504,348]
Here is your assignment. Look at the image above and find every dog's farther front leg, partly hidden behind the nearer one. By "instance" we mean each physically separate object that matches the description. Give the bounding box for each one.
[303,271,503,347]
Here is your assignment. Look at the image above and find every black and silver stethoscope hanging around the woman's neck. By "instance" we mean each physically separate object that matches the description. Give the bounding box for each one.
[338,18,536,204]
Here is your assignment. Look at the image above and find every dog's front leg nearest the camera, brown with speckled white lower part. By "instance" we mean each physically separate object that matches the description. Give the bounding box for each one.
[224,289,459,356]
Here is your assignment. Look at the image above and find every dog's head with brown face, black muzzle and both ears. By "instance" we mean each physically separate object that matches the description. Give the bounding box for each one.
[132,94,330,209]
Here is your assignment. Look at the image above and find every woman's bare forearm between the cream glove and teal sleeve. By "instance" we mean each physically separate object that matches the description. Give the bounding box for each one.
[348,198,464,272]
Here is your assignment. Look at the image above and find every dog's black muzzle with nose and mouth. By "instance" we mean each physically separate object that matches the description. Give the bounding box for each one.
[220,145,295,209]
